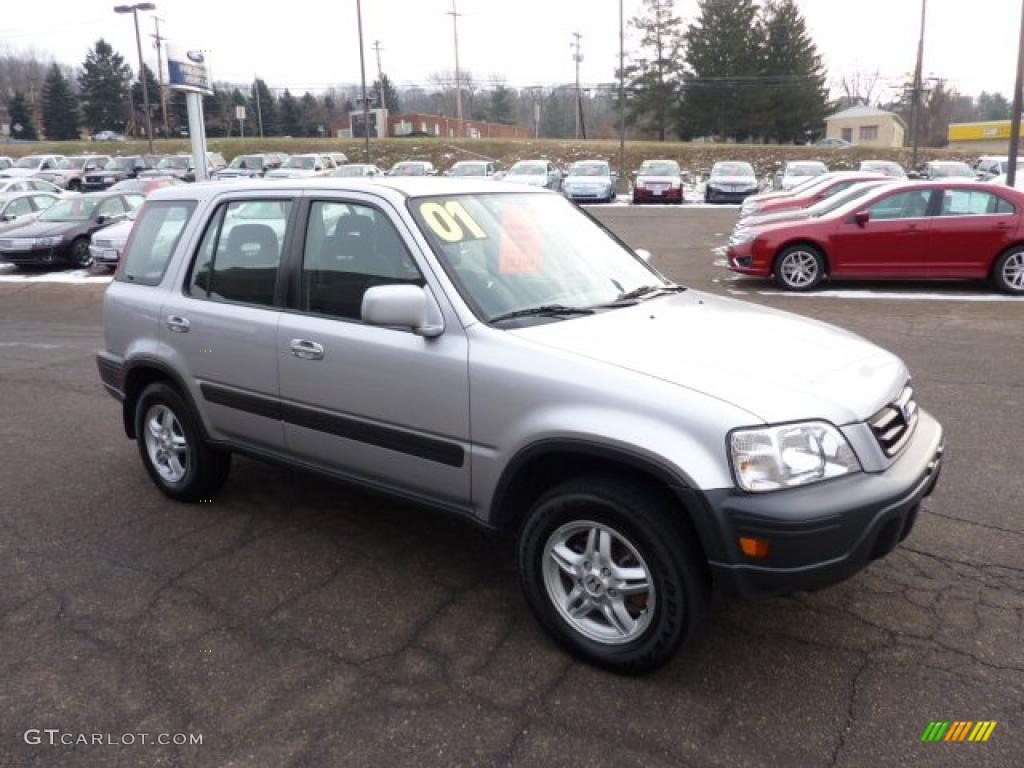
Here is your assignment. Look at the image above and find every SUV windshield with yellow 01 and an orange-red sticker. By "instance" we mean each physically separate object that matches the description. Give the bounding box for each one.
[410,193,671,322]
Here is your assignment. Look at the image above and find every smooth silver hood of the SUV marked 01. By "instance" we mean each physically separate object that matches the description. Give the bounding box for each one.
[510,291,908,425]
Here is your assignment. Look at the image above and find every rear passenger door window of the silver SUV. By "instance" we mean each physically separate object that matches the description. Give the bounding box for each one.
[188,200,292,306]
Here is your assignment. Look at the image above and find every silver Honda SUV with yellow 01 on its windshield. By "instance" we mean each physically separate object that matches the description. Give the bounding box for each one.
[98,178,943,673]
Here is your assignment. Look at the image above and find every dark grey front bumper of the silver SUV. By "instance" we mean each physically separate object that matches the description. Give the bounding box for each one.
[698,411,944,597]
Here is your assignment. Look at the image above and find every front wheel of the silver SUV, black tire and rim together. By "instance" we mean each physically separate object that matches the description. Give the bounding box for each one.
[519,477,708,674]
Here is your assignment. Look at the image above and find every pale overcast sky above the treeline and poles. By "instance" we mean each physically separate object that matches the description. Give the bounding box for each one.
[0,0,1021,97]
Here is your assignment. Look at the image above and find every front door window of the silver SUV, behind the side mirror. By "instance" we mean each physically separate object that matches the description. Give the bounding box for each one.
[299,202,424,321]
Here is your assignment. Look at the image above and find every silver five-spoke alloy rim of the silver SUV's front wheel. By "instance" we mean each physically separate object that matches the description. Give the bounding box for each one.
[543,520,655,645]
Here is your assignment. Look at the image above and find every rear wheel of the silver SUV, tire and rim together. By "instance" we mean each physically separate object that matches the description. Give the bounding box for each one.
[135,382,231,502]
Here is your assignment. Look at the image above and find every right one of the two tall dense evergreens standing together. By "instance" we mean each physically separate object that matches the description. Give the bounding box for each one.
[761,0,829,143]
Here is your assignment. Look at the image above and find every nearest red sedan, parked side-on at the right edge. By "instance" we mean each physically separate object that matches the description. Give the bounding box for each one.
[728,180,1024,295]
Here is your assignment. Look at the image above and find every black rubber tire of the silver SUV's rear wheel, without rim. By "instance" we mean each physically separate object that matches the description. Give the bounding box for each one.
[134,382,231,502]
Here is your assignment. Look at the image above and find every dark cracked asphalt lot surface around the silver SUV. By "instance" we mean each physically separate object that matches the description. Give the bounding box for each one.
[0,207,1024,768]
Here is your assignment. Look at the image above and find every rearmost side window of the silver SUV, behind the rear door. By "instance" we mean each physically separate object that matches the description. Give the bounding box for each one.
[115,200,196,286]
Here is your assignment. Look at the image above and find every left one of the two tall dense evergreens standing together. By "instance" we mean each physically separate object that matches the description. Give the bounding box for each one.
[679,0,763,138]
